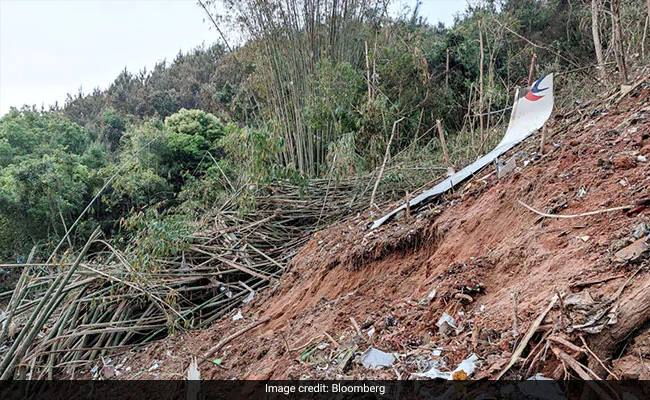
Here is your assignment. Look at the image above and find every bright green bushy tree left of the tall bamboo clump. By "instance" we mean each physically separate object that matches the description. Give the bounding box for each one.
[102,110,226,216]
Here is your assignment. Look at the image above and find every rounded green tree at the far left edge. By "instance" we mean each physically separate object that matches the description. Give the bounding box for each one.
[0,109,105,258]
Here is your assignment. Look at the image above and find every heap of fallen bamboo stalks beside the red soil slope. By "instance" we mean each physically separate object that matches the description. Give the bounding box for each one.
[0,175,408,378]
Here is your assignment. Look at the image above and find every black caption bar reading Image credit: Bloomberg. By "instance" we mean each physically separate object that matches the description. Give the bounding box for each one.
[0,380,650,400]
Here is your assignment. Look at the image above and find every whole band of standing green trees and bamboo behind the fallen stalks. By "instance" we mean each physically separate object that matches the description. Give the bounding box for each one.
[0,0,647,268]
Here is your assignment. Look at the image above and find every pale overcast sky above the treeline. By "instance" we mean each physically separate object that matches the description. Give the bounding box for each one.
[0,0,467,116]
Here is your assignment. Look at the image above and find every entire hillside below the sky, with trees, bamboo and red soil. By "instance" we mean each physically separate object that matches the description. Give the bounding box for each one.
[0,0,650,383]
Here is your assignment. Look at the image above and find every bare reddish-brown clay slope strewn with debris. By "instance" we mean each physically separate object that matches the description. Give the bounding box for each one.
[104,82,650,379]
